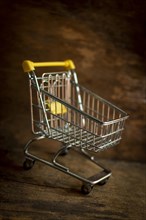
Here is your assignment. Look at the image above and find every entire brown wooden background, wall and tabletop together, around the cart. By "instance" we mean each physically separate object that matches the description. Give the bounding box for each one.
[0,0,146,220]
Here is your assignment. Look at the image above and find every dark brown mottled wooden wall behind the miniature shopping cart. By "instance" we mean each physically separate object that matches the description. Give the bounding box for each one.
[0,0,146,162]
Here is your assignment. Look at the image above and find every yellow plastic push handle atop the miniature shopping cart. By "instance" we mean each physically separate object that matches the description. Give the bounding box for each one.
[22,60,75,73]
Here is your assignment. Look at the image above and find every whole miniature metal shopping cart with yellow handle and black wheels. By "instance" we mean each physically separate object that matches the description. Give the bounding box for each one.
[23,60,128,194]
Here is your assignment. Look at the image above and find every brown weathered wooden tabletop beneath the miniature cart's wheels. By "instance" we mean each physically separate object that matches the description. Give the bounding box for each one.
[0,138,146,220]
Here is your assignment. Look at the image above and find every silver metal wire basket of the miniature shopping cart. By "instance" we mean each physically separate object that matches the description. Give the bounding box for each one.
[30,71,127,152]
